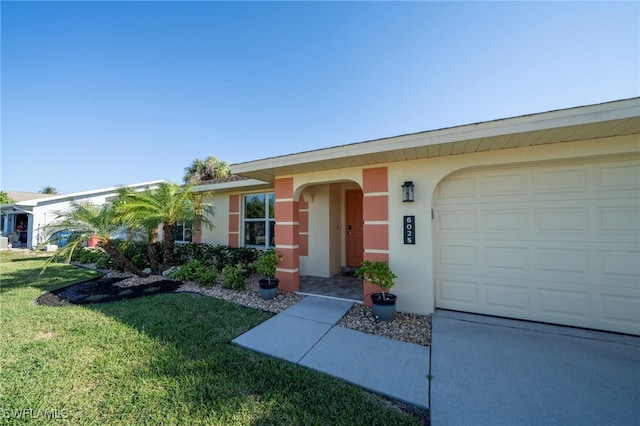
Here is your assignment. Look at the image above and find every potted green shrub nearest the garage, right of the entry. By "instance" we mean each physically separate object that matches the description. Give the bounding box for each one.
[356,260,397,321]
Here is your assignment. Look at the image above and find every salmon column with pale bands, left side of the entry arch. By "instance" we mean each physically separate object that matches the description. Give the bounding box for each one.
[275,178,300,291]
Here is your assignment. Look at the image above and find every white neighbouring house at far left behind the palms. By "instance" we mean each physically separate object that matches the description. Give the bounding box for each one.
[0,180,163,249]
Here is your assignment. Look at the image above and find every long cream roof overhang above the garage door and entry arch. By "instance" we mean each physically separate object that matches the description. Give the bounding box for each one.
[231,98,640,182]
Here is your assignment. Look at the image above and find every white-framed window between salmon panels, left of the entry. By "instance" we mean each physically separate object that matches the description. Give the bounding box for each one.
[242,192,276,248]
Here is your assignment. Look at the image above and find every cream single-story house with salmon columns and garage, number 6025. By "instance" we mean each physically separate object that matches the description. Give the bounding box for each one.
[198,98,640,335]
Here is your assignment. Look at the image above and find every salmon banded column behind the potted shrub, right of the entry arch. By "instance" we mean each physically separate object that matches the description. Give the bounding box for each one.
[362,167,389,306]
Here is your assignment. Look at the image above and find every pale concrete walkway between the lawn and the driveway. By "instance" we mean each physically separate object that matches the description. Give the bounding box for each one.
[233,296,429,408]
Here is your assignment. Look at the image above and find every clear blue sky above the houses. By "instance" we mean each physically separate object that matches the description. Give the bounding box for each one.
[0,1,640,193]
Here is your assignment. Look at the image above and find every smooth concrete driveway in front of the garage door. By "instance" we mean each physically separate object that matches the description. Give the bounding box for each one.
[430,311,640,426]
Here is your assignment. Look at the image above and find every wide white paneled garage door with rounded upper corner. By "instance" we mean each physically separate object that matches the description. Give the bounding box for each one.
[434,157,640,335]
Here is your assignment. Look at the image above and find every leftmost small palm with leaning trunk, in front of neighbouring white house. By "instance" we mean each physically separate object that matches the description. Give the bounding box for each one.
[45,201,145,276]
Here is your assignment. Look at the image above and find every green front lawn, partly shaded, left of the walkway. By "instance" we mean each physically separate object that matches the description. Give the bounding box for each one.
[0,252,419,425]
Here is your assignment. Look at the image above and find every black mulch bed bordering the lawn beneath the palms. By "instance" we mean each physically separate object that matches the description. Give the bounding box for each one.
[36,277,182,306]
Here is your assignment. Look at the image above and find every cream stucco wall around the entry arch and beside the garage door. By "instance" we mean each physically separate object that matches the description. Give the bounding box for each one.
[286,136,640,314]
